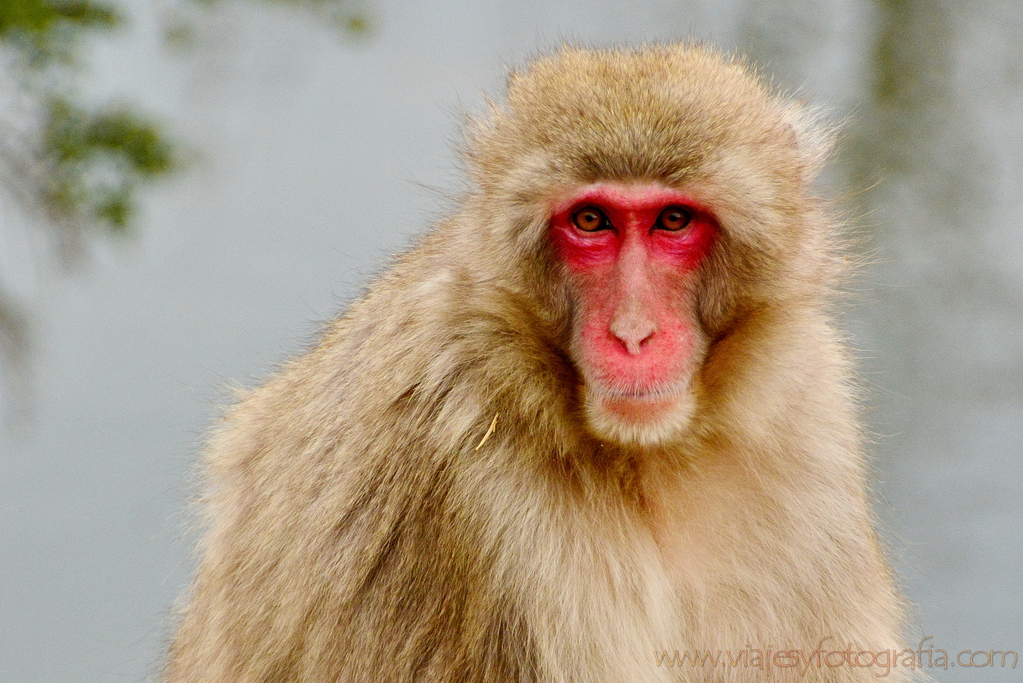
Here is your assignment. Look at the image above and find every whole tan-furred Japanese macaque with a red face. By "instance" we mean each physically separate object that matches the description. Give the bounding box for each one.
[164,45,913,683]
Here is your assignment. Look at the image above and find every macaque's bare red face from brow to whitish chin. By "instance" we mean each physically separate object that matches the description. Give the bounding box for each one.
[551,184,717,442]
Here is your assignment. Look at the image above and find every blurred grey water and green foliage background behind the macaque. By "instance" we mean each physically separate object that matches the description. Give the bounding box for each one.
[0,0,1023,683]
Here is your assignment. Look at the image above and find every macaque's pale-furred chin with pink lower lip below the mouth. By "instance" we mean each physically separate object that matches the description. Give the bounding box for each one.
[583,381,697,447]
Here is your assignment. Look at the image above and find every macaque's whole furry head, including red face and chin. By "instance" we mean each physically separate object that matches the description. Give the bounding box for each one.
[466,46,834,446]
